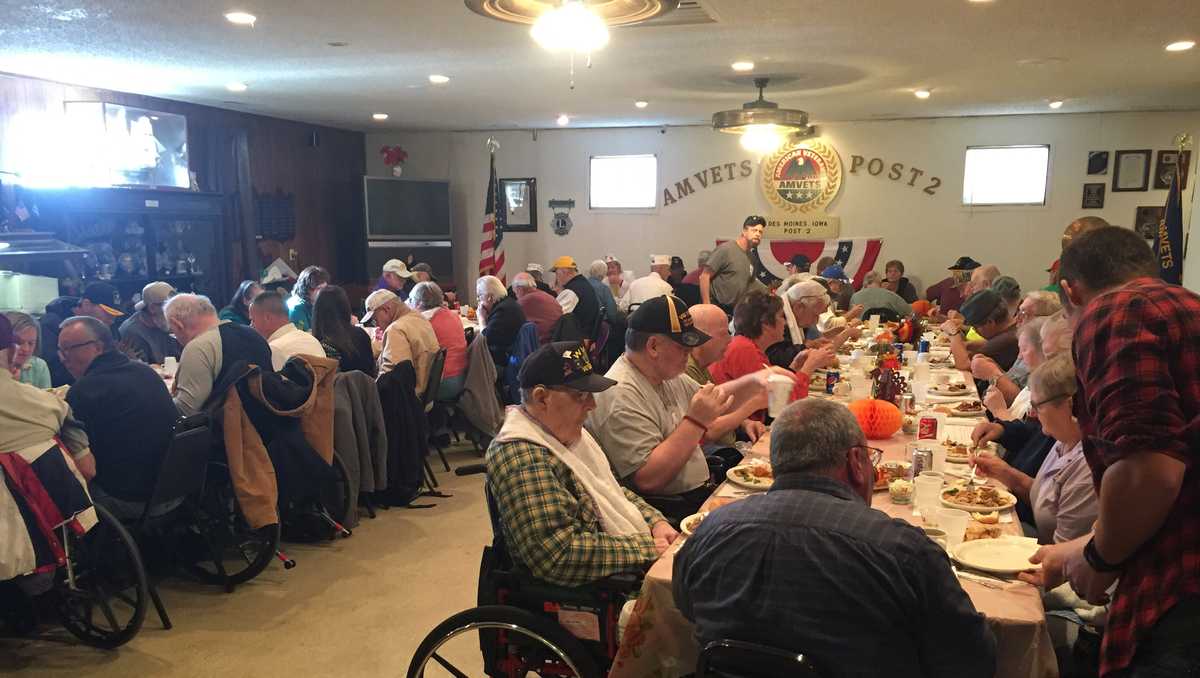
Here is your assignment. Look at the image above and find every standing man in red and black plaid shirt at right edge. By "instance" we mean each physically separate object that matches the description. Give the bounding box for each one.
[1033,227,1200,678]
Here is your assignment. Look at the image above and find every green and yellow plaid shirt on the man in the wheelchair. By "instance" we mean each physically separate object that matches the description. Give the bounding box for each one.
[487,440,664,586]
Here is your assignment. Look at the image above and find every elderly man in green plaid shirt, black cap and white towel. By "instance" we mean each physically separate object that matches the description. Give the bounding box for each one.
[487,342,678,586]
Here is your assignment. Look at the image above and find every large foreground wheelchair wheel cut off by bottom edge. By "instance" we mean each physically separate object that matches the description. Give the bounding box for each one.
[408,605,601,678]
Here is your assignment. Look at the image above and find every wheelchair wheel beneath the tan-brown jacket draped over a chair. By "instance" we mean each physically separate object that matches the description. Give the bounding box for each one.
[186,470,280,590]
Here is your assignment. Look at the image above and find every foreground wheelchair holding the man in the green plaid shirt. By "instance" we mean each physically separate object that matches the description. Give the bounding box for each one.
[407,492,642,678]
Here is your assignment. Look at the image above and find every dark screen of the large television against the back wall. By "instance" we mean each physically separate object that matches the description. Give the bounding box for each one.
[362,176,450,240]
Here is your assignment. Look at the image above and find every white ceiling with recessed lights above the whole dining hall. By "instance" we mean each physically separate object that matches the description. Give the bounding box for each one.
[0,0,1200,130]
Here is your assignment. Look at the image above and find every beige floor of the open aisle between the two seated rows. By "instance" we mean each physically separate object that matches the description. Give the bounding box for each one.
[0,448,491,678]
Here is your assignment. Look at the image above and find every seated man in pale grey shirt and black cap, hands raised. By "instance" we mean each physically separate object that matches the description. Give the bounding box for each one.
[587,295,767,522]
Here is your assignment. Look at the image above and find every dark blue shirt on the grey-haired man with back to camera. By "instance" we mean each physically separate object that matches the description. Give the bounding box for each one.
[673,473,996,678]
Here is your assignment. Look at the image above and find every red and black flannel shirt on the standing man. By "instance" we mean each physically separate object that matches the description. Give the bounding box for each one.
[1073,277,1200,676]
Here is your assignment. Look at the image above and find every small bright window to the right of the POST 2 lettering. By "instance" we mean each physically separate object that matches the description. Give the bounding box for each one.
[962,146,1050,205]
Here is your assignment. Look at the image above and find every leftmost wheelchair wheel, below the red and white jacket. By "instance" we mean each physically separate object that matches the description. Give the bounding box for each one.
[54,504,150,649]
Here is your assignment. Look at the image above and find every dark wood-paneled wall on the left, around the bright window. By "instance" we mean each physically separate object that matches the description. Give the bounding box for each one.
[0,73,367,285]
